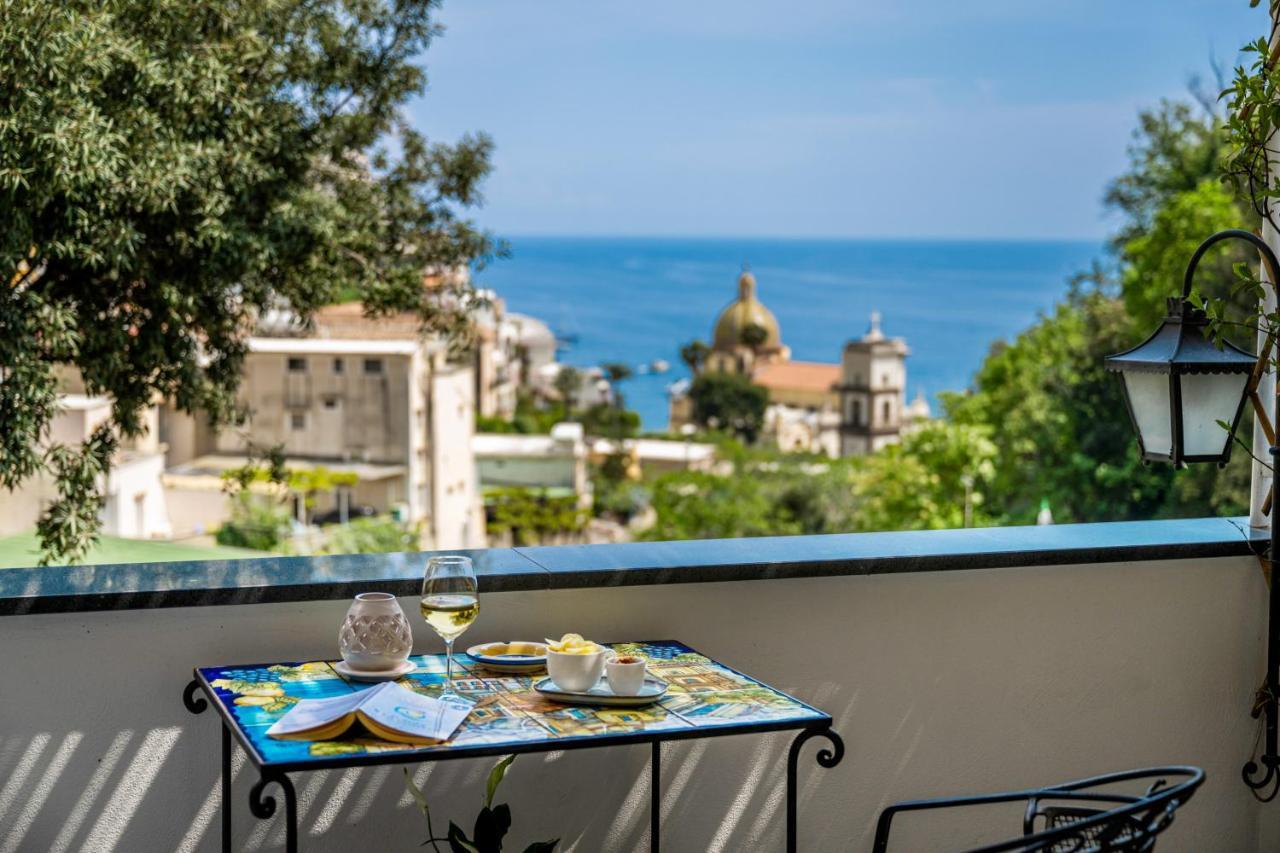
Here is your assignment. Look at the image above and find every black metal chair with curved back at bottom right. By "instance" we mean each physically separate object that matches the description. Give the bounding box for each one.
[872,767,1204,853]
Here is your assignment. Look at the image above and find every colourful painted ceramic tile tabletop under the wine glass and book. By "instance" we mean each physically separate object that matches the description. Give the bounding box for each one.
[197,640,827,767]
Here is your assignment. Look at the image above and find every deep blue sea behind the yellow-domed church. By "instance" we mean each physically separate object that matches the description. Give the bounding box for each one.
[475,237,1103,430]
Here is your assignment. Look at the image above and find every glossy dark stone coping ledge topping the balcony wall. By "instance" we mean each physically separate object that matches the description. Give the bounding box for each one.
[0,519,1268,616]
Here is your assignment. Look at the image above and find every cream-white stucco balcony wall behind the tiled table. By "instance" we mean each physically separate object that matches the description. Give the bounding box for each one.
[0,558,1280,853]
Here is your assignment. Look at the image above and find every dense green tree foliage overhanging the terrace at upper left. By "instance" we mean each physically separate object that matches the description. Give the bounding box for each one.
[0,0,500,560]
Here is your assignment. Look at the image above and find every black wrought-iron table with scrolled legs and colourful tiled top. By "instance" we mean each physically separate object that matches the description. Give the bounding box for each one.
[183,640,845,853]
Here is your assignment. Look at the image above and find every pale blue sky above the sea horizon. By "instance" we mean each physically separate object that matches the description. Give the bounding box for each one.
[412,0,1266,240]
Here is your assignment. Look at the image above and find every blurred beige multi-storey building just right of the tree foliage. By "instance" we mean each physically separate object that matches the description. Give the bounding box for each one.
[163,309,485,548]
